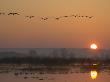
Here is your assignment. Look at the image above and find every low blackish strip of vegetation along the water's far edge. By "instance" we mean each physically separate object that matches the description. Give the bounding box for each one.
[0,56,110,65]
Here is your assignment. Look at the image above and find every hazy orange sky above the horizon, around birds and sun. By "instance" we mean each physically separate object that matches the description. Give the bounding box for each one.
[0,0,110,48]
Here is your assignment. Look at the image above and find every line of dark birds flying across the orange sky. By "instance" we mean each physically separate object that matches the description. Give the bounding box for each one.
[0,12,93,21]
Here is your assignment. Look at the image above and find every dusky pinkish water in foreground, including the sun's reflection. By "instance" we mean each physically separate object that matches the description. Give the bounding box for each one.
[0,64,110,82]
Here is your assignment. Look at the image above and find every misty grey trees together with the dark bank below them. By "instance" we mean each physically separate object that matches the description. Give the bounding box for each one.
[0,48,110,65]
